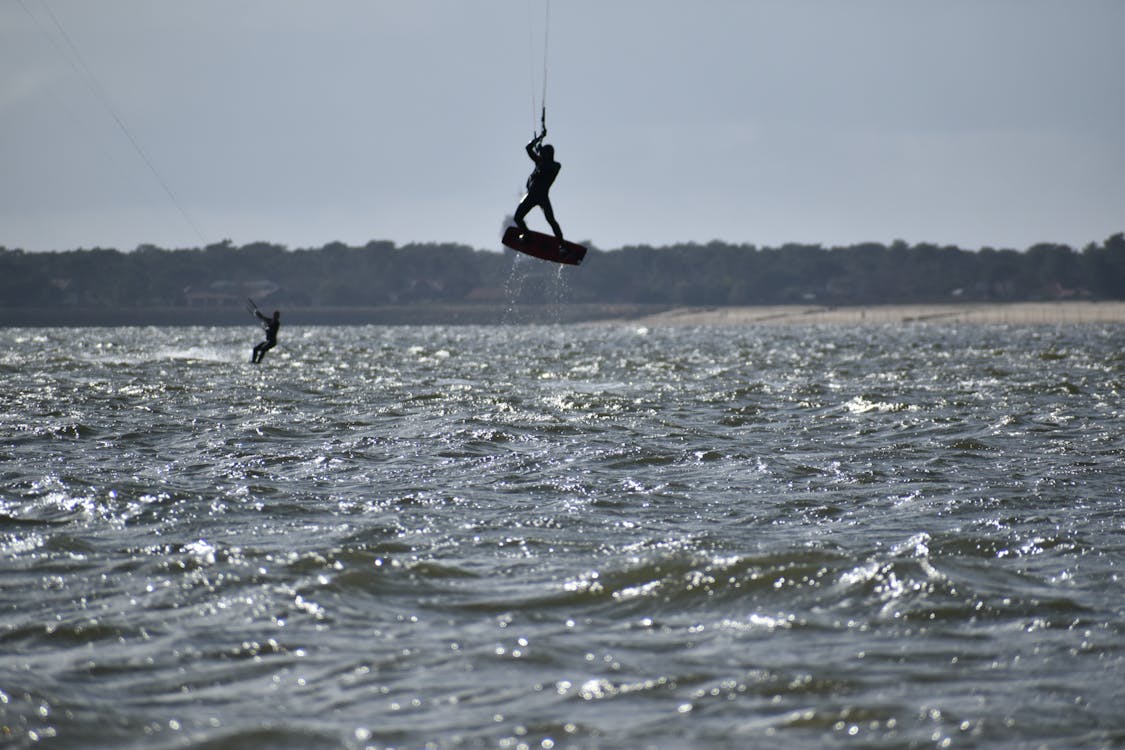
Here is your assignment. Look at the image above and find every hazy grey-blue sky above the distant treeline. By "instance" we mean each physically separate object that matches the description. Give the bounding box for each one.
[0,0,1125,251]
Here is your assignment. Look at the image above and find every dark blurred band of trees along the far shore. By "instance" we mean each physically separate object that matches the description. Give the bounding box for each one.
[0,234,1125,309]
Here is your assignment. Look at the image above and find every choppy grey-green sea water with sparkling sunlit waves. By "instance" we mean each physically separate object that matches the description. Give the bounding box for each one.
[0,324,1125,750]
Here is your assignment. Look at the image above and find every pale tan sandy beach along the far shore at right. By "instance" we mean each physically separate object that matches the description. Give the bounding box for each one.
[633,301,1125,326]
